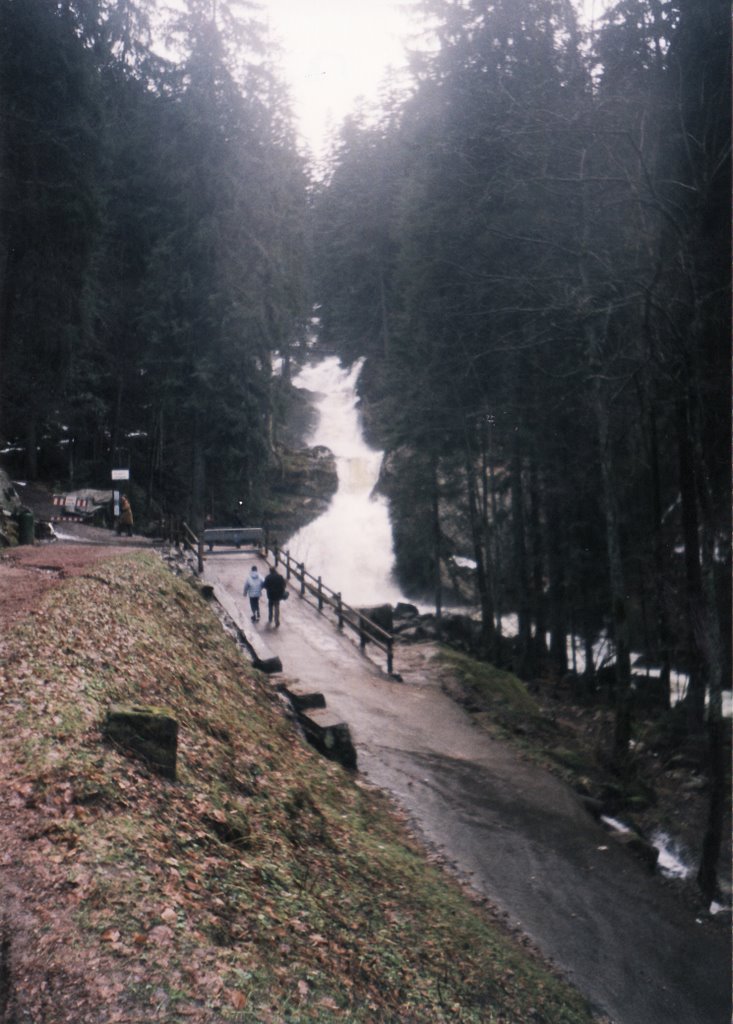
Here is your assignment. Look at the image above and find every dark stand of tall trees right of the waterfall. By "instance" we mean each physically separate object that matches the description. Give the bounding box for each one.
[313,0,730,737]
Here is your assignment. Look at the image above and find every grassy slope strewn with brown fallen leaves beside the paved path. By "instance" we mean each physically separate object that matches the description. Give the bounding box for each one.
[0,555,591,1024]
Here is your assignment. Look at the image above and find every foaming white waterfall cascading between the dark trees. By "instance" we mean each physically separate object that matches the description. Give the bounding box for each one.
[287,356,404,607]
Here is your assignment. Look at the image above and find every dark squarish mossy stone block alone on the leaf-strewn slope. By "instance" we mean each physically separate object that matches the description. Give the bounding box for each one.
[103,705,178,781]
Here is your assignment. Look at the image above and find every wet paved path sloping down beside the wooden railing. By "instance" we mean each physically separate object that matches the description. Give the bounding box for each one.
[206,551,731,1024]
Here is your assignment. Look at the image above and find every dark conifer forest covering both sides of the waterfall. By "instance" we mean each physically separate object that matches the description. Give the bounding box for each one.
[0,0,731,892]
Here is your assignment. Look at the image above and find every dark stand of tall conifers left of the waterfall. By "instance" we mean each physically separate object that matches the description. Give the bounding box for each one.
[0,0,307,521]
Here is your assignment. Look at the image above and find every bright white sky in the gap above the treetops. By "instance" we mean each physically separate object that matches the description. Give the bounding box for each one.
[260,0,608,159]
